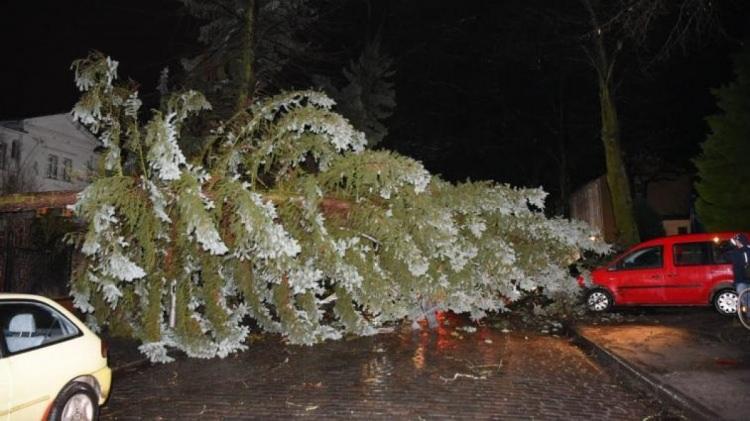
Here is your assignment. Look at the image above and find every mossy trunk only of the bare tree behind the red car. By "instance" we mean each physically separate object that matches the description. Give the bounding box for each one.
[599,78,640,245]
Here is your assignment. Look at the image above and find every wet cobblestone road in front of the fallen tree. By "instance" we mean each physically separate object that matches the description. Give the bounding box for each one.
[102,319,661,420]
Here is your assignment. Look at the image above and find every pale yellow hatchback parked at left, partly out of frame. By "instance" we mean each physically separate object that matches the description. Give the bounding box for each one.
[0,293,112,420]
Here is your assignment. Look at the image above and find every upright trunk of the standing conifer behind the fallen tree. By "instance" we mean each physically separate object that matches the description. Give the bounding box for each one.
[234,0,258,113]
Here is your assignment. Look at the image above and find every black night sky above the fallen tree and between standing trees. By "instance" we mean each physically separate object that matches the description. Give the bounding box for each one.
[0,0,750,210]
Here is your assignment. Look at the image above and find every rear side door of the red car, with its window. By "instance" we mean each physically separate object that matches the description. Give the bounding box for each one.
[664,241,712,305]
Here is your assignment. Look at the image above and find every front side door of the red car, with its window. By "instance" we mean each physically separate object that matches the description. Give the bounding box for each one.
[607,245,665,305]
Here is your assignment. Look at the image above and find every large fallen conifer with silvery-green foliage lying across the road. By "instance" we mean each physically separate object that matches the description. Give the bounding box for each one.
[73,52,607,361]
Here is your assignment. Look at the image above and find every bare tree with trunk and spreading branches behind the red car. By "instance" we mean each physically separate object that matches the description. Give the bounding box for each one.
[558,0,721,244]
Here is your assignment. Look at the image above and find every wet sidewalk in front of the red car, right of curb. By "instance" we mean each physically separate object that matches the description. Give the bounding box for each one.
[572,309,750,420]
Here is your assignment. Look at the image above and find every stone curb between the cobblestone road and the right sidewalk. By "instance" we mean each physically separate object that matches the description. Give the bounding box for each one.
[566,326,721,420]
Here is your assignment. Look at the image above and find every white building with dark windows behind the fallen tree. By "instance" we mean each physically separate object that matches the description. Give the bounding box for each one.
[0,114,100,194]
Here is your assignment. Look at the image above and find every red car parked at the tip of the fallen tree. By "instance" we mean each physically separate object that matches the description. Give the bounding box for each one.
[579,232,748,315]
